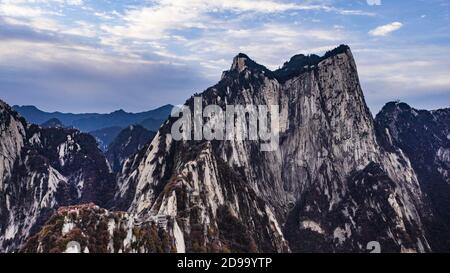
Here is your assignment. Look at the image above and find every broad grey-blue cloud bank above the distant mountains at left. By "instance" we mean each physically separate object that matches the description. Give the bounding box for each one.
[0,37,212,112]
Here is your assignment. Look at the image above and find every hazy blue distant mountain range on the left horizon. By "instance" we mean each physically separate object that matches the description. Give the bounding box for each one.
[12,104,173,151]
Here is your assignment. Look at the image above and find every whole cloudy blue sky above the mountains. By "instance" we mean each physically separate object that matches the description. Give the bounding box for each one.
[0,0,450,114]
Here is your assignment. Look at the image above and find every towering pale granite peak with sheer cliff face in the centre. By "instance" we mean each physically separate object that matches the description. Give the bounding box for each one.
[116,46,430,252]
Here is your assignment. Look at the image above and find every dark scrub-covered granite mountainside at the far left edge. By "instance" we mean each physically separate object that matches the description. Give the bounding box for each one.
[0,102,115,252]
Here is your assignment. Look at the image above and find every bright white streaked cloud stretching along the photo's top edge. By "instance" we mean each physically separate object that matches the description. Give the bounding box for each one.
[102,0,373,40]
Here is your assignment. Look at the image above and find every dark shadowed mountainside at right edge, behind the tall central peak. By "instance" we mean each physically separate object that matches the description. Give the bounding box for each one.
[376,102,450,251]
